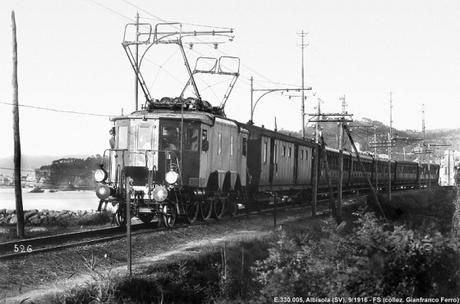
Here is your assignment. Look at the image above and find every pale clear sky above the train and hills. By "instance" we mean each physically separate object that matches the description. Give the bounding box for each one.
[0,0,460,157]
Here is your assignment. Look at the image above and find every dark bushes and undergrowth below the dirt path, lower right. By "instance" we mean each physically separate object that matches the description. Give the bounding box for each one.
[30,189,460,303]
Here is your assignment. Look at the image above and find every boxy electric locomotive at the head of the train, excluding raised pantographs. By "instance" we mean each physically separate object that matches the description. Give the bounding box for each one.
[95,98,248,226]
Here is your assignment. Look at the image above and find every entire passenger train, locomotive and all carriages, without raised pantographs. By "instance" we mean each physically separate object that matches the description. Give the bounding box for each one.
[95,98,439,227]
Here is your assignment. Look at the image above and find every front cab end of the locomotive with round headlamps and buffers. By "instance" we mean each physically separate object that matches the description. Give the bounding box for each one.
[95,112,207,225]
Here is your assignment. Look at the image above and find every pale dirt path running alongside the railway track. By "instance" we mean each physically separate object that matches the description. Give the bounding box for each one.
[0,207,328,304]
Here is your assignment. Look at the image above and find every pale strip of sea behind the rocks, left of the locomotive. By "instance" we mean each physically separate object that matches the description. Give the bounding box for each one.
[0,188,100,211]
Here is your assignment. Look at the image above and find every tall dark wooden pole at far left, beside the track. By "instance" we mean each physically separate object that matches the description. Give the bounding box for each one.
[11,11,24,238]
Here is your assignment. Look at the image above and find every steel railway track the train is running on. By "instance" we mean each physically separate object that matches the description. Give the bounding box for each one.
[0,195,365,260]
